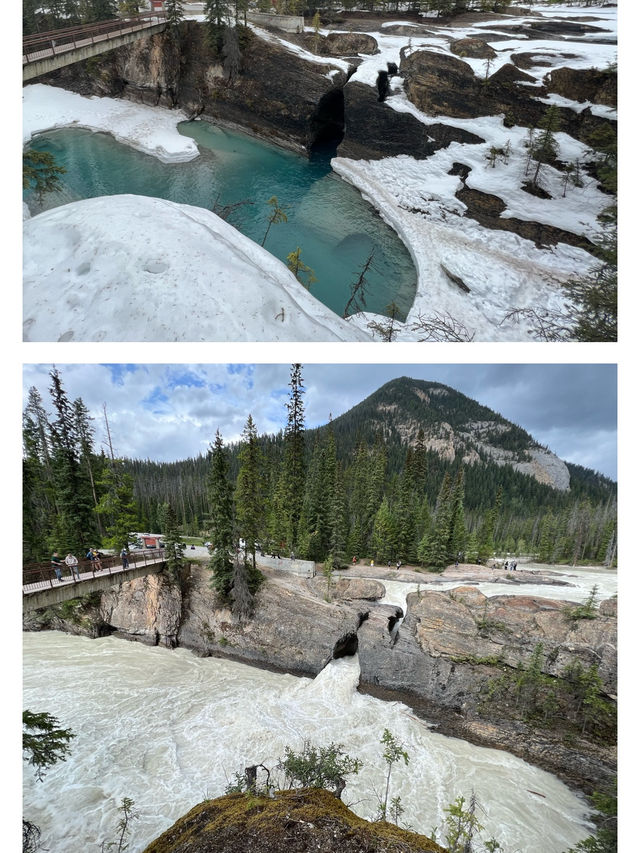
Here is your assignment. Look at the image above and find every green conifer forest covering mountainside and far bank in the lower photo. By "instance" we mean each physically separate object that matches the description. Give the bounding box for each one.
[23,364,617,568]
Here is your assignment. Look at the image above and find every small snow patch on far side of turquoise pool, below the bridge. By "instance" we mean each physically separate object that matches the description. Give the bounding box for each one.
[23,83,199,163]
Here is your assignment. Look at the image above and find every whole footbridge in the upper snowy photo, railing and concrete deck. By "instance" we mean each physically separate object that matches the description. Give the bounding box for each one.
[22,11,166,82]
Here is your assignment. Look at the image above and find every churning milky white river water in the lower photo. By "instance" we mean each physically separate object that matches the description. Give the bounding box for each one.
[24,632,589,853]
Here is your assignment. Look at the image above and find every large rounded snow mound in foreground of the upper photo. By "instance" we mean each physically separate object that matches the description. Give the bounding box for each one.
[23,195,371,341]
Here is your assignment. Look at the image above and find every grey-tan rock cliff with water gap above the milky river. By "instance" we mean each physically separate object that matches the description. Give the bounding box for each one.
[24,566,617,793]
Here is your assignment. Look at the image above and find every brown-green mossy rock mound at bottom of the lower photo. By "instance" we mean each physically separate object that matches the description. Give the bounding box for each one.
[144,788,445,853]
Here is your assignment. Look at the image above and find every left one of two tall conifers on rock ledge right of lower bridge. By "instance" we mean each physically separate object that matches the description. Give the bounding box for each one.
[209,430,233,601]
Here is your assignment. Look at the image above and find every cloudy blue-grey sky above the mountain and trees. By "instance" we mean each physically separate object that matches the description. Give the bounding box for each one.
[24,364,617,479]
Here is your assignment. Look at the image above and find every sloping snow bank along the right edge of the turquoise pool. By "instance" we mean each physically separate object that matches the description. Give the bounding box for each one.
[332,155,594,341]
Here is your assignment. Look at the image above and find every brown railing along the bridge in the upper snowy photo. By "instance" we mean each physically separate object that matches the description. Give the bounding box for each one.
[22,12,166,65]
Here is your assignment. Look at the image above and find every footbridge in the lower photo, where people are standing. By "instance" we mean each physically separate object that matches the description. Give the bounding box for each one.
[22,549,165,613]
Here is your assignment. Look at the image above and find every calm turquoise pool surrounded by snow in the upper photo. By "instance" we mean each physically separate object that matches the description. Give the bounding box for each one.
[28,121,416,319]
